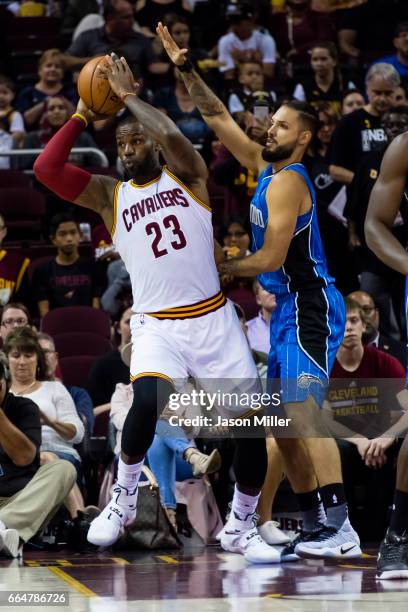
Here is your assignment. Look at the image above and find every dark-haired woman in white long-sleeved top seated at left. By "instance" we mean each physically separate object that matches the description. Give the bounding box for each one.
[4,327,84,518]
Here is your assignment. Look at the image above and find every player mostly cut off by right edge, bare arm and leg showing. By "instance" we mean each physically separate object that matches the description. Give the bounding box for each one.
[365,133,408,580]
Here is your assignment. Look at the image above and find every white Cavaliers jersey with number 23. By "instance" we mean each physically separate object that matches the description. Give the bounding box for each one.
[112,166,225,318]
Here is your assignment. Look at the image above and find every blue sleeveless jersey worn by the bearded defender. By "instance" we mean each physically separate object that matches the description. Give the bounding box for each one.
[250,164,334,295]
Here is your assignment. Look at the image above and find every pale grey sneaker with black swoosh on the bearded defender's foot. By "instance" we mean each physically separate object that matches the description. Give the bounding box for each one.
[295,518,362,559]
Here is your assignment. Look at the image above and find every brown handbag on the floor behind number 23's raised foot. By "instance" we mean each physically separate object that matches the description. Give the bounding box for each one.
[114,466,182,550]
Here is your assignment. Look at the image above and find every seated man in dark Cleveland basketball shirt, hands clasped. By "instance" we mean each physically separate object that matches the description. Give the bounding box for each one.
[325,298,408,537]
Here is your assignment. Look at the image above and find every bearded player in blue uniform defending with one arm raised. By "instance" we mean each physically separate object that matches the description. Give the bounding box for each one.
[157,24,361,560]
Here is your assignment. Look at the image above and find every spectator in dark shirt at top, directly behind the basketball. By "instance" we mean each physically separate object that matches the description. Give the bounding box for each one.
[63,0,168,79]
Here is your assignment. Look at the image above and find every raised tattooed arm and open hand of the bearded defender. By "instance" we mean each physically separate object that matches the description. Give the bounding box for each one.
[156,23,267,173]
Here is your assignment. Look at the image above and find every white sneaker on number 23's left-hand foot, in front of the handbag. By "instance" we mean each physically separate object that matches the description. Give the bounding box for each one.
[87,484,137,546]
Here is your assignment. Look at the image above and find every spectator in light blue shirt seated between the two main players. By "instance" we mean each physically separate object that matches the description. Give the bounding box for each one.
[247,280,276,355]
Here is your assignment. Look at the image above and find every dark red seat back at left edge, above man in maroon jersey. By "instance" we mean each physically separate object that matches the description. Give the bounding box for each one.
[0,187,45,240]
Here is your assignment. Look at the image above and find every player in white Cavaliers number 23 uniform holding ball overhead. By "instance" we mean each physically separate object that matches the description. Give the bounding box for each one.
[34,56,280,563]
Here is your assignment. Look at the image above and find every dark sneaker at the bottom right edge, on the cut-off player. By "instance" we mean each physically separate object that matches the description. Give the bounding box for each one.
[376,528,408,580]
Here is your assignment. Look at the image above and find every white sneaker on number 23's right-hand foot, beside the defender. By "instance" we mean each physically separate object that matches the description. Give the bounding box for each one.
[219,513,280,563]
